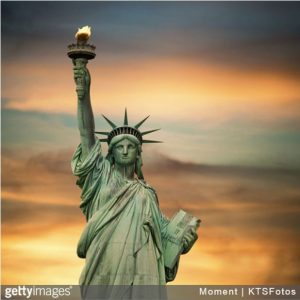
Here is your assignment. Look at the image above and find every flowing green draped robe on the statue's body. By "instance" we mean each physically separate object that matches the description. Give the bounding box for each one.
[71,140,178,285]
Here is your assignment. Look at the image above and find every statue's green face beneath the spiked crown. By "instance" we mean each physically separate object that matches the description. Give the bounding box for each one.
[113,138,138,165]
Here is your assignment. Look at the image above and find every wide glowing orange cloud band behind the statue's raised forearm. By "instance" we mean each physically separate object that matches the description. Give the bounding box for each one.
[3,59,300,120]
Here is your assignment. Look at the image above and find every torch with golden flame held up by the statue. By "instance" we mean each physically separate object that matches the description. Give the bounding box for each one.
[68,26,96,96]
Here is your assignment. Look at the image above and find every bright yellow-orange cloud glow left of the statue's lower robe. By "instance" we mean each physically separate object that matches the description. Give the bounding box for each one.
[2,226,84,285]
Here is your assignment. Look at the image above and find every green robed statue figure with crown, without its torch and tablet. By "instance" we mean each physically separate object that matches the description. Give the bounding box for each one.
[71,26,197,285]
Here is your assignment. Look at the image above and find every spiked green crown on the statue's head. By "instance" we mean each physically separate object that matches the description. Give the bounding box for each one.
[95,108,161,145]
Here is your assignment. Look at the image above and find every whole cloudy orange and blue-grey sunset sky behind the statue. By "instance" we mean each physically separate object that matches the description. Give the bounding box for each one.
[1,1,300,284]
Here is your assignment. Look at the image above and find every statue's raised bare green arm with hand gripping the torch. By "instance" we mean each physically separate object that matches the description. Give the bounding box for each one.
[73,58,95,158]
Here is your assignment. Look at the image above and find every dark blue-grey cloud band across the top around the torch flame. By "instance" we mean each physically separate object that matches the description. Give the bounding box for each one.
[2,2,300,73]
